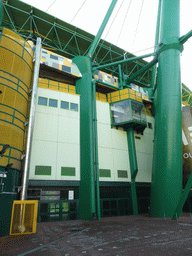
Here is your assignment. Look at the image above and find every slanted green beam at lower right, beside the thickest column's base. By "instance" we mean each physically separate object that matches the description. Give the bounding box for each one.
[172,173,192,220]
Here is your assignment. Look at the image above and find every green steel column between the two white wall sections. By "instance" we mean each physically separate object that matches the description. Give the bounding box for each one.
[73,56,96,220]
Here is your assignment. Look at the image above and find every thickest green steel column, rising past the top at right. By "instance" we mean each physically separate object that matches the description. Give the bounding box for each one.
[150,0,182,217]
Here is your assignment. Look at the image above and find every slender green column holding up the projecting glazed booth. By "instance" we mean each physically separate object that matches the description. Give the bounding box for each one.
[127,127,138,215]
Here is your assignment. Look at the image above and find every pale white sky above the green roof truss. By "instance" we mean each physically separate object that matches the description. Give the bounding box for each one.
[20,0,192,90]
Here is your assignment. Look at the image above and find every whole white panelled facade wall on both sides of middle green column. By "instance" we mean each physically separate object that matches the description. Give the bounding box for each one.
[29,88,154,182]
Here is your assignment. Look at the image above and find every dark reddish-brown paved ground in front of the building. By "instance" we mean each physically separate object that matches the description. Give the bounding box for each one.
[0,213,192,256]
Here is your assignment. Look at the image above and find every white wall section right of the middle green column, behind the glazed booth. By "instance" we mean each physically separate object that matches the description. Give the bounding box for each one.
[97,101,154,182]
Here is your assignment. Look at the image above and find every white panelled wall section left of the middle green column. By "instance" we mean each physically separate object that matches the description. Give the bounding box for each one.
[29,88,80,180]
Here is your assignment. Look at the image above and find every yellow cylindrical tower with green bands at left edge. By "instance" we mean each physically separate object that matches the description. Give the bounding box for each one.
[0,28,33,170]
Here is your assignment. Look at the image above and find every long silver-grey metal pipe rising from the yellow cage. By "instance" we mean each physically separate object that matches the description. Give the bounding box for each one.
[21,37,41,200]
